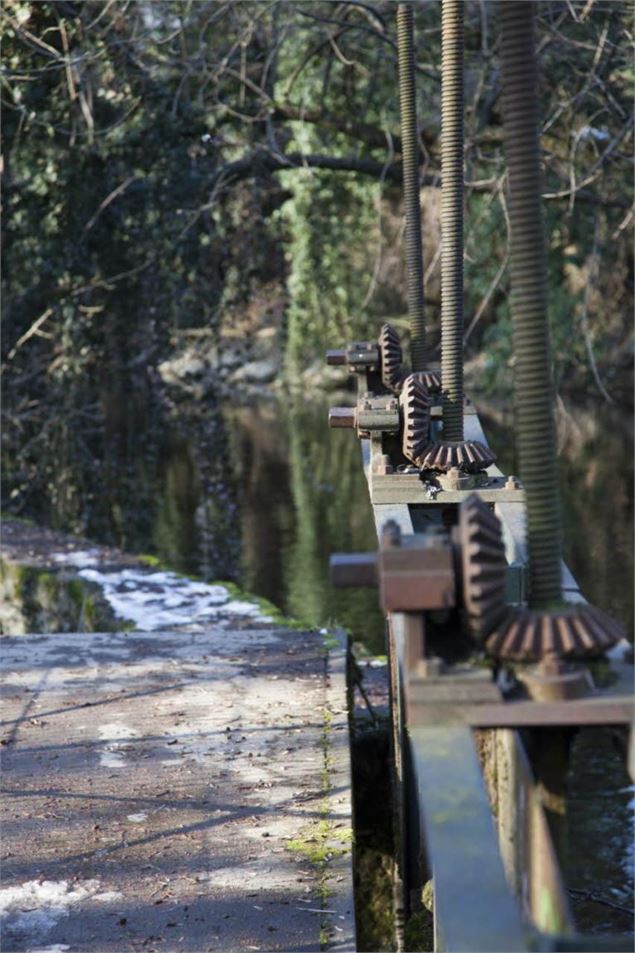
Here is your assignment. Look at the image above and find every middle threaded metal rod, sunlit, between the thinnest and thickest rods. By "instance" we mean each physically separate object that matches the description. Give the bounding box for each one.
[441,0,463,440]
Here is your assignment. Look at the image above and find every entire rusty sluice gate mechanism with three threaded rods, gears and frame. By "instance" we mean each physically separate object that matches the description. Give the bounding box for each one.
[327,0,632,951]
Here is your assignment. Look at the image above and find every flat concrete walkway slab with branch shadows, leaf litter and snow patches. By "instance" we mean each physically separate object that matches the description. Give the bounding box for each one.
[0,619,355,953]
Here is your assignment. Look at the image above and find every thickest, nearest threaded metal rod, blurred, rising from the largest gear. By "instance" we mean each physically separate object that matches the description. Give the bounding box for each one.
[499,0,562,609]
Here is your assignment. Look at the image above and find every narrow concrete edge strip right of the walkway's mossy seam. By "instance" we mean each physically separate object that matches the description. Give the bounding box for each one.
[325,629,357,953]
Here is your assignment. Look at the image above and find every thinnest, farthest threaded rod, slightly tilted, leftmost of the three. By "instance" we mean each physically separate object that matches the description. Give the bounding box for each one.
[397,3,427,371]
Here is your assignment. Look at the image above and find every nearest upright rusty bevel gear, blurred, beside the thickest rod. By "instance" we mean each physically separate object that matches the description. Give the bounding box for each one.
[459,493,508,642]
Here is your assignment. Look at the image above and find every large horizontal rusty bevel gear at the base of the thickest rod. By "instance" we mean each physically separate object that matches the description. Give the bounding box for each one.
[485,603,624,661]
